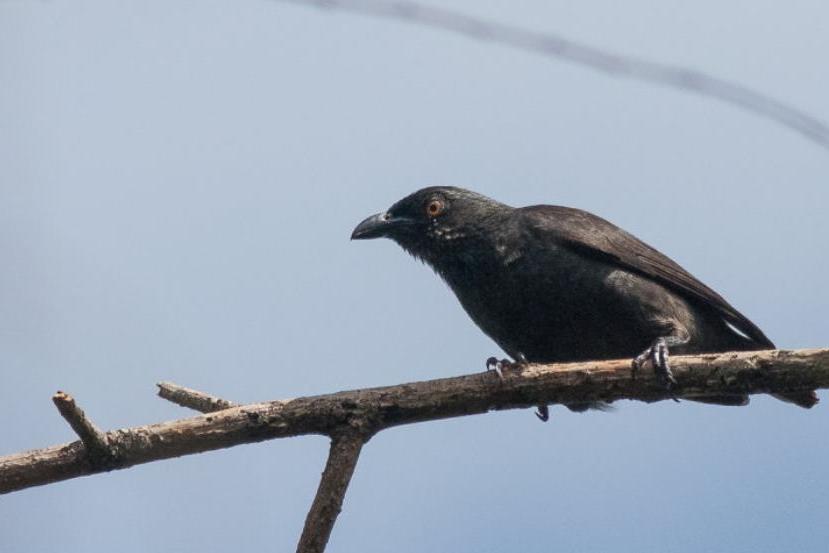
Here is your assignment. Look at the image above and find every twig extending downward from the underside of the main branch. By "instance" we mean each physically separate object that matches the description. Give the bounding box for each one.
[296,432,365,553]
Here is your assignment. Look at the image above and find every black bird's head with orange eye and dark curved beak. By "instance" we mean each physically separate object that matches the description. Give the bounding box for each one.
[351,186,510,265]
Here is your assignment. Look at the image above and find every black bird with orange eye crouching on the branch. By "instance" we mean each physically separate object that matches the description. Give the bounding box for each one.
[351,187,818,414]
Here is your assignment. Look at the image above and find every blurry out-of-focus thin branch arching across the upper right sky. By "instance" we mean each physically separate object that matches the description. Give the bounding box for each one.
[277,0,829,149]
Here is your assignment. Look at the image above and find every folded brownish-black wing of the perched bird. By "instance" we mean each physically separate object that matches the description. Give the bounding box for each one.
[520,205,774,348]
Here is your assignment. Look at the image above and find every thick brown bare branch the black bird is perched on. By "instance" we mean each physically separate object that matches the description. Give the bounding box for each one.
[0,349,829,493]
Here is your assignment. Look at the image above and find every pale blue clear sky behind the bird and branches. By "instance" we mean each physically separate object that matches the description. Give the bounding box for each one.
[0,0,829,553]
